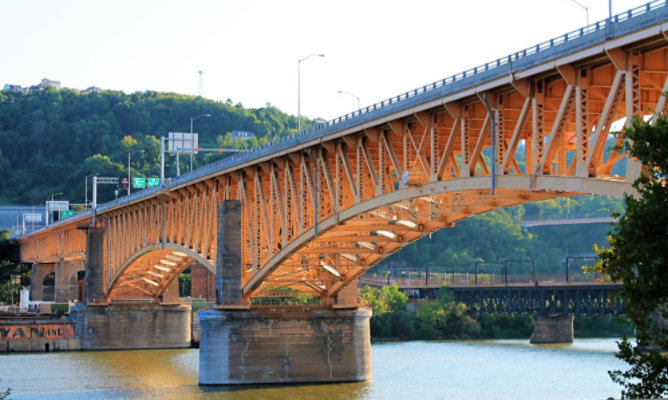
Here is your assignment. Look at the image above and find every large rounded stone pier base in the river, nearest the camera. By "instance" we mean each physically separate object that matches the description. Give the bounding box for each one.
[199,307,371,385]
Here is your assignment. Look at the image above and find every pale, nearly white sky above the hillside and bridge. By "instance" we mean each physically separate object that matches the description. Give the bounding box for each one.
[0,0,645,119]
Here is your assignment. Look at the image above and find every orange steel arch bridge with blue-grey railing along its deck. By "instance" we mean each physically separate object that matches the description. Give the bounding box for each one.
[18,1,668,305]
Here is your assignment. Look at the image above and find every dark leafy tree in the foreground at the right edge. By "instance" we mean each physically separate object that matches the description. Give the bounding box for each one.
[597,115,668,398]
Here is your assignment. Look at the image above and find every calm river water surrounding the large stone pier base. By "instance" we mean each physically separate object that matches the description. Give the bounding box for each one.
[0,339,624,400]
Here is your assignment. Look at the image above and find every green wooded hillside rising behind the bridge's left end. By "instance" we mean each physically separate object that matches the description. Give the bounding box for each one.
[0,87,314,204]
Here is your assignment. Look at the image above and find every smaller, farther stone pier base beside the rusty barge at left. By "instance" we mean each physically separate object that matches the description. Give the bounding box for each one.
[70,303,191,350]
